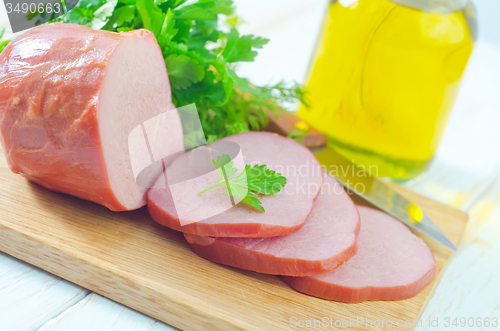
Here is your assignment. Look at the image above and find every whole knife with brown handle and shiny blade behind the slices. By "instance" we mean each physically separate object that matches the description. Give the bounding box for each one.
[264,113,457,251]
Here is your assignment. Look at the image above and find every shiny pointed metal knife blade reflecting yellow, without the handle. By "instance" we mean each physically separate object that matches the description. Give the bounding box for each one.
[311,146,457,251]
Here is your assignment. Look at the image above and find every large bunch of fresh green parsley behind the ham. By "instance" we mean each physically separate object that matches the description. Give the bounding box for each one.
[5,0,304,143]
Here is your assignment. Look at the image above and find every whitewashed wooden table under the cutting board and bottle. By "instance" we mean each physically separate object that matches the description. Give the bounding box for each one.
[0,0,500,331]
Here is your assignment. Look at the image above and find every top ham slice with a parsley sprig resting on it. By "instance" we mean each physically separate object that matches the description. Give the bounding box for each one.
[148,132,323,237]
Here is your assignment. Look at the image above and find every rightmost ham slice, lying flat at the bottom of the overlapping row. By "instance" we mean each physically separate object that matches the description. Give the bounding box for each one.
[283,207,436,303]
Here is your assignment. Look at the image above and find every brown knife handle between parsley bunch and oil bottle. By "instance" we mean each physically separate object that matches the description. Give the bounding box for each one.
[263,111,327,148]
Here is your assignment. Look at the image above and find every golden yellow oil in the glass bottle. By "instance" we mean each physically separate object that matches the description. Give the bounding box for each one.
[299,0,473,179]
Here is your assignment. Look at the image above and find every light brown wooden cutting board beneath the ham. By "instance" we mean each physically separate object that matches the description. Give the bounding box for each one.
[0,150,467,330]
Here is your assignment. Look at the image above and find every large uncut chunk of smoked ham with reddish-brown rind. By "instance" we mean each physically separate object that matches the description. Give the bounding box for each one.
[0,23,183,211]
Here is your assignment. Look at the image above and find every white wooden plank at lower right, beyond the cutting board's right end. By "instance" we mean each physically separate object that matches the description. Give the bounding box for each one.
[412,181,500,330]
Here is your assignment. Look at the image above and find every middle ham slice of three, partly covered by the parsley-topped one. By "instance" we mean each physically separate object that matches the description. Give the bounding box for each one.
[184,175,359,276]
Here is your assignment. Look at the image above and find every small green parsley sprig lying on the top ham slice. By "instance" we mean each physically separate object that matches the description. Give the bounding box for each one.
[198,154,286,212]
